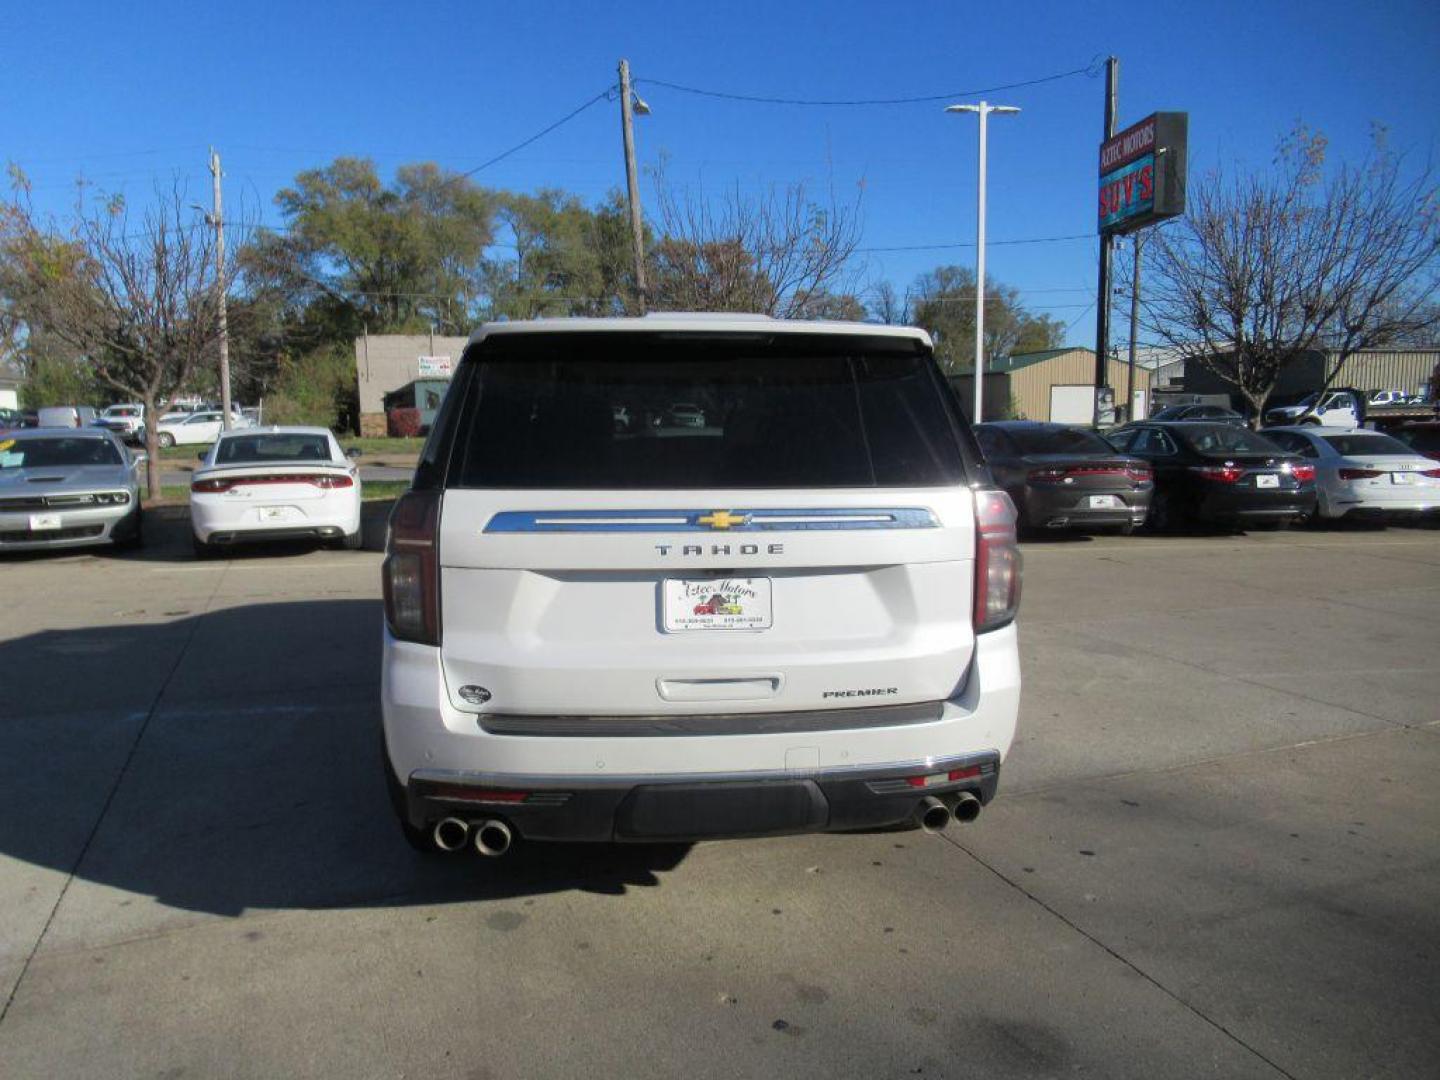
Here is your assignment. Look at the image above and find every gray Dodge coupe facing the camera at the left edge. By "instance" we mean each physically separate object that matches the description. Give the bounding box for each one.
[0,428,144,552]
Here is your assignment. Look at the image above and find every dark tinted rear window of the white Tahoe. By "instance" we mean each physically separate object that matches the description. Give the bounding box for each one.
[448,334,965,488]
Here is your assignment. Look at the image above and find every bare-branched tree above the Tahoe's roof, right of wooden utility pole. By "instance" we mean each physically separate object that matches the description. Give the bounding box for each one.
[652,168,860,318]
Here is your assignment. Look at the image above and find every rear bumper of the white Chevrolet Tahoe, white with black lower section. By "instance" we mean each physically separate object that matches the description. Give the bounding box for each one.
[382,625,1020,841]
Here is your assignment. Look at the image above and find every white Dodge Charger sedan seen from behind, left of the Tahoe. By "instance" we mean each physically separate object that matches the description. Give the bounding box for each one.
[190,428,360,556]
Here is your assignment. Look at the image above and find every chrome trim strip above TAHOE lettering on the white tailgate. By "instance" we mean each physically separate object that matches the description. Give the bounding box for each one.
[484,507,940,536]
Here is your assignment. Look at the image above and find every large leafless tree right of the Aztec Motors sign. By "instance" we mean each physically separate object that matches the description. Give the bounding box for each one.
[1142,127,1440,420]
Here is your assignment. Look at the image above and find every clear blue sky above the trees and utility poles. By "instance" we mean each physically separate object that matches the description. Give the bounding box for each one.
[0,0,1440,344]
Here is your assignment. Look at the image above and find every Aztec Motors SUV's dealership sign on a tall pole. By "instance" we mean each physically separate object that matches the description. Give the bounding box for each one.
[1100,112,1189,235]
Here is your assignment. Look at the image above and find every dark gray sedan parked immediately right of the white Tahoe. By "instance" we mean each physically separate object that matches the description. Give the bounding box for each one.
[975,420,1153,533]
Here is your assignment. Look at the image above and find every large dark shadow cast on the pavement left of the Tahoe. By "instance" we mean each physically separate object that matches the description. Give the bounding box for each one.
[0,599,688,922]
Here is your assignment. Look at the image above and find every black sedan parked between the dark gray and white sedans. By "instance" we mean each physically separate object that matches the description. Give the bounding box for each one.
[1106,420,1315,531]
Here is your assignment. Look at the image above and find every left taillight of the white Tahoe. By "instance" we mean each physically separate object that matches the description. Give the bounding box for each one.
[380,491,441,645]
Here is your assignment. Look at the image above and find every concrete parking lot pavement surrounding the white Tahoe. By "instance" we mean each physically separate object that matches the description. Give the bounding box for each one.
[0,508,1440,1080]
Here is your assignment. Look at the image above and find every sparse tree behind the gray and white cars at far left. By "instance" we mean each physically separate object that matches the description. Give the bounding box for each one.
[0,173,230,498]
